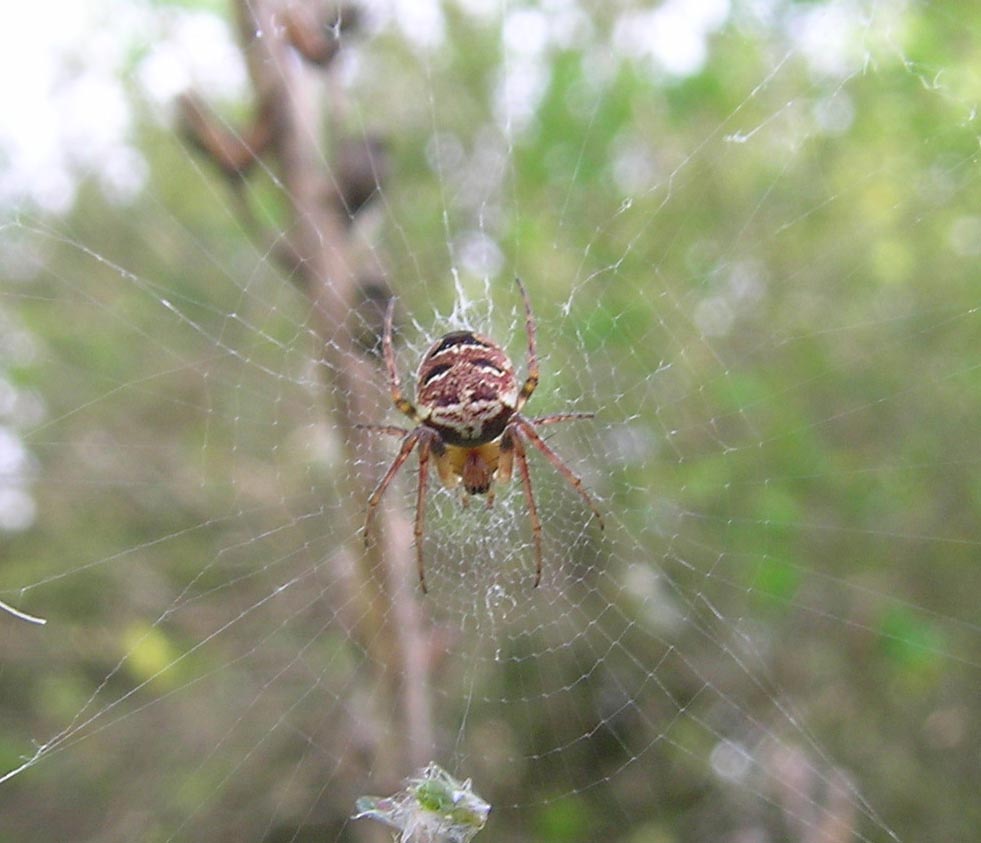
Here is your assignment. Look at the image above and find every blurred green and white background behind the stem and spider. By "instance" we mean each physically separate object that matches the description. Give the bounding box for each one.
[0,0,981,843]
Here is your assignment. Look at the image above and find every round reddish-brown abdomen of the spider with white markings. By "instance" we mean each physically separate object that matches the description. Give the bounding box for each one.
[416,331,518,447]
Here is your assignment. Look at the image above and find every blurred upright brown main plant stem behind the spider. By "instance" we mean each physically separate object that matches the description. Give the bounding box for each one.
[224,0,433,792]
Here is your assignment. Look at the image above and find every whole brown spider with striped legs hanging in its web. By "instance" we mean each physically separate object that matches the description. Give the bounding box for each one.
[359,278,603,594]
